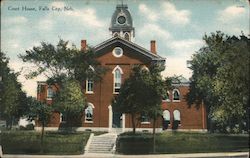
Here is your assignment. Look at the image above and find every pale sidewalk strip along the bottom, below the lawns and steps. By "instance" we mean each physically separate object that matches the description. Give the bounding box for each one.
[3,152,249,158]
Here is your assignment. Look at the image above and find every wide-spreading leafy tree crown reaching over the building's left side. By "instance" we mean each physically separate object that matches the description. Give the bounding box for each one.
[19,39,105,87]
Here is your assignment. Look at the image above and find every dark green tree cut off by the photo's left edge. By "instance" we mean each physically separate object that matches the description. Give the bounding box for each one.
[0,52,26,129]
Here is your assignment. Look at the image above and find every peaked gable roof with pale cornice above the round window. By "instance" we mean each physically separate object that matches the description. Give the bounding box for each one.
[94,37,165,62]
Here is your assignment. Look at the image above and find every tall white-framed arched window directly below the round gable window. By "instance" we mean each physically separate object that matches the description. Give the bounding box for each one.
[112,65,123,94]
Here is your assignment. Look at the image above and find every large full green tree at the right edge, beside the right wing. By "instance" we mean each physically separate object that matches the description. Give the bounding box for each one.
[188,32,250,132]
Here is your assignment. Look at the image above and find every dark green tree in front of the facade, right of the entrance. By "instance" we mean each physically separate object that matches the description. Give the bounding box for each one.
[112,65,165,136]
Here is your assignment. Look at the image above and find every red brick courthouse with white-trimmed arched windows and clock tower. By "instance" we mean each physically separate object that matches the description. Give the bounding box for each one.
[37,5,206,131]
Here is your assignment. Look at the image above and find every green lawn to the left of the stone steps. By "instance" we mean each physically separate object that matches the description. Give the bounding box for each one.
[0,131,90,155]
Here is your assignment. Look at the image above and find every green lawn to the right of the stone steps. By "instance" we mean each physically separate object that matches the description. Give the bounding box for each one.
[117,132,249,154]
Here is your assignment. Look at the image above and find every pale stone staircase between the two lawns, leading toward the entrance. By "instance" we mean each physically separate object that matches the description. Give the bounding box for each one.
[85,133,117,154]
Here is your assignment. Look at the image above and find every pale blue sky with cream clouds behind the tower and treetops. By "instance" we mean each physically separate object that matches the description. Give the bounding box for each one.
[1,0,249,97]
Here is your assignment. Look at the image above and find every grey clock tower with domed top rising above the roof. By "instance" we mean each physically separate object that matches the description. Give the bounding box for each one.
[109,4,135,41]
